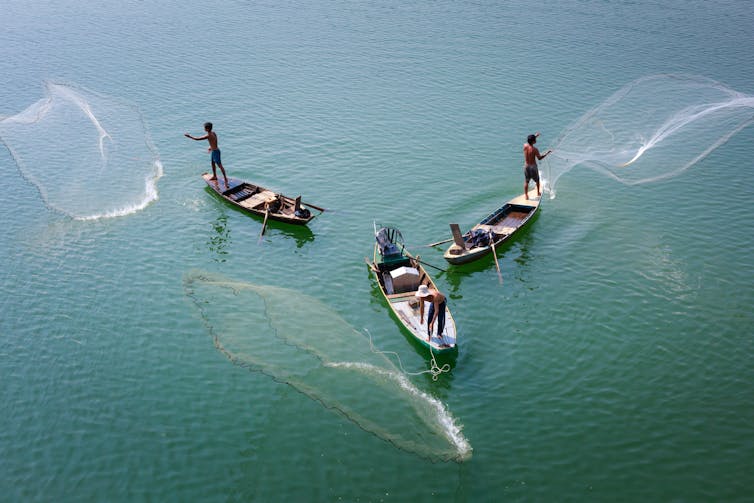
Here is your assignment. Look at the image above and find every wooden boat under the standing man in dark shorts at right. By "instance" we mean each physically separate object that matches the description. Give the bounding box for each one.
[443,188,541,264]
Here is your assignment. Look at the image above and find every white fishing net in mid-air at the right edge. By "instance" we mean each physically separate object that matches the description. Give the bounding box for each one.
[543,75,754,198]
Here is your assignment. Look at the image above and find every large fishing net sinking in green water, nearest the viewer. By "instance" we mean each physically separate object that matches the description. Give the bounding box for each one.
[184,271,472,462]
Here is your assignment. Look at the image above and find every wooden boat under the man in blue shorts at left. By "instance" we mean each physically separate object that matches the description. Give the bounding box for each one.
[202,173,324,225]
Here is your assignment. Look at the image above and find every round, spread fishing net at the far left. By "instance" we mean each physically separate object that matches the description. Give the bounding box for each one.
[0,82,163,220]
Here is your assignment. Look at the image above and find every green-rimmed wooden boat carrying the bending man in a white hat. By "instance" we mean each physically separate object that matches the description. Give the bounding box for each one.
[365,225,456,353]
